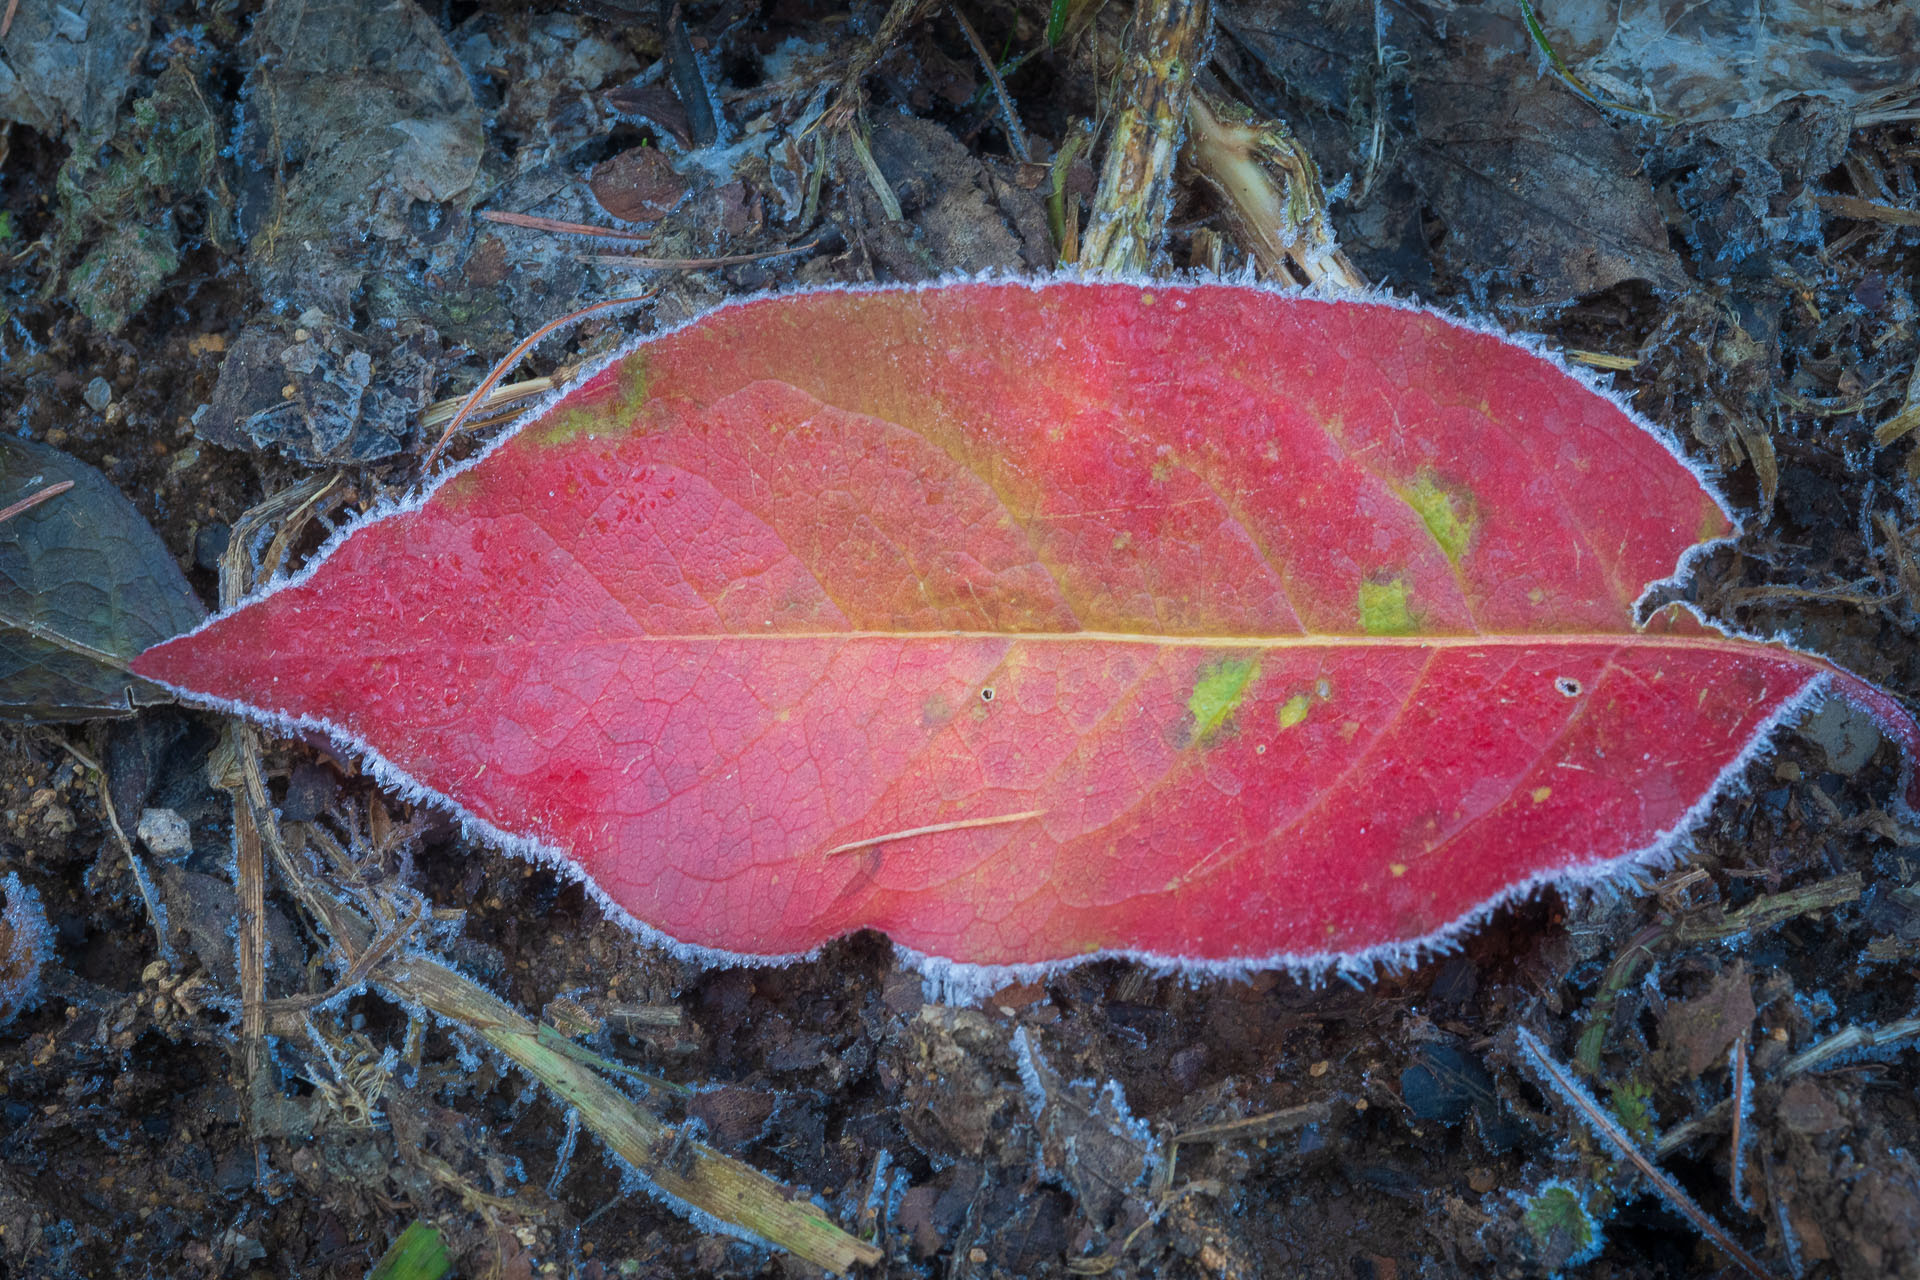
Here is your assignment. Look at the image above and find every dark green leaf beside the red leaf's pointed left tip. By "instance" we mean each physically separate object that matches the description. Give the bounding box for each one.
[0,438,205,720]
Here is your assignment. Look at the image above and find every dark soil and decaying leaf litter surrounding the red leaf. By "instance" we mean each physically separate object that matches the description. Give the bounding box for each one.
[0,0,1920,1274]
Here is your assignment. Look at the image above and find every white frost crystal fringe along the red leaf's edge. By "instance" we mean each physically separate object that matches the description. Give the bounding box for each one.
[152,274,1912,1004]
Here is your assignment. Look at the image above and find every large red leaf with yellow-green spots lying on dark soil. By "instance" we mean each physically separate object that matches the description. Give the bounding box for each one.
[134,284,1920,965]
